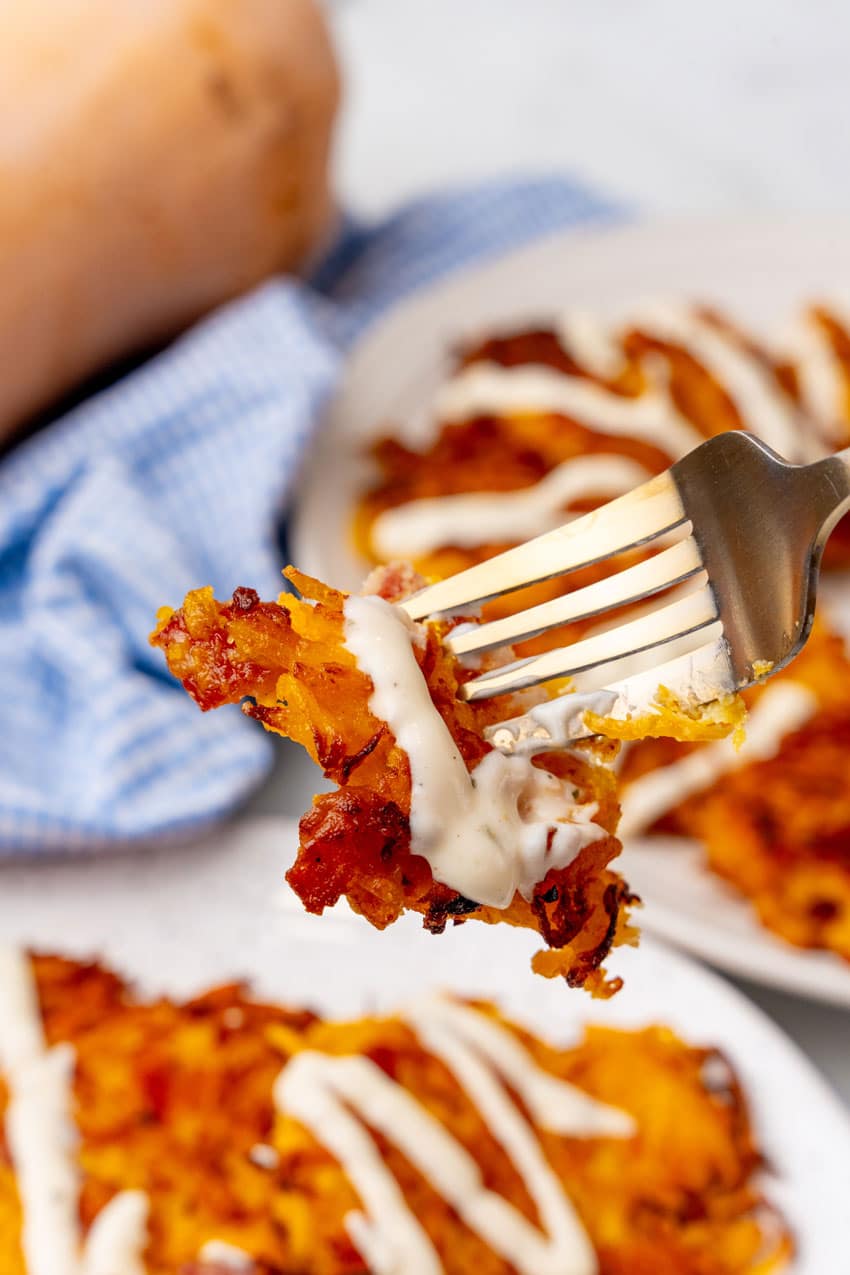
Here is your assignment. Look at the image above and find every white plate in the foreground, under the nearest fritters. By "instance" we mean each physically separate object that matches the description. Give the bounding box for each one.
[0,819,850,1275]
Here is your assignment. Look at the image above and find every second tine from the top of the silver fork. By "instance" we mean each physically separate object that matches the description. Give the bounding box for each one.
[446,537,707,655]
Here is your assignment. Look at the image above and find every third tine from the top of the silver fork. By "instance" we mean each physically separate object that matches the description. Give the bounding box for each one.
[460,585,717,700]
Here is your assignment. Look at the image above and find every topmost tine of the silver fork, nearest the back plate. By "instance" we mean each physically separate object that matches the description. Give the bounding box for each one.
[400,472,687,620]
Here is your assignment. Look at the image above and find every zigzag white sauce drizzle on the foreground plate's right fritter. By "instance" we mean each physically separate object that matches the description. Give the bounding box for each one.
[274,998,635,1275]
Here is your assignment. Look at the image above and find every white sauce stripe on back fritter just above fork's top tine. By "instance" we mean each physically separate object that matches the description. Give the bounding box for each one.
[371,455,651,561]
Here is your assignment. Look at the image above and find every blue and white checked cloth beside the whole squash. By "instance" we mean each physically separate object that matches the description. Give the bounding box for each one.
[0,179,617,854]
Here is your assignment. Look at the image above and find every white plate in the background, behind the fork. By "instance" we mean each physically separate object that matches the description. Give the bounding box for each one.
[291,218,850,1006]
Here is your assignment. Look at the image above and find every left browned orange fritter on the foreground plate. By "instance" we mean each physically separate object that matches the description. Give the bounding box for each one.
[0,955,313,1275]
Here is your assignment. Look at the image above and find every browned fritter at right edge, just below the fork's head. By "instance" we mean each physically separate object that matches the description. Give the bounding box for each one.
[621,621,850,960]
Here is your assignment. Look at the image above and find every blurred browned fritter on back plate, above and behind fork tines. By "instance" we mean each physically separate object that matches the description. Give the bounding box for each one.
[353,307,850,655]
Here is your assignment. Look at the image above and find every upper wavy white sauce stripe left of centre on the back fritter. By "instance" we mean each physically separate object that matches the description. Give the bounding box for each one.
[435,361,703,459]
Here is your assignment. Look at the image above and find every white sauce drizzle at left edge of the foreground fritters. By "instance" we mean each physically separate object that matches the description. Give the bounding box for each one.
[0,946,147,1275]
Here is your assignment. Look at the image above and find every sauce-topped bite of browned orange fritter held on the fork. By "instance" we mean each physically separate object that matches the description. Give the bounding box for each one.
[152,566,749,996]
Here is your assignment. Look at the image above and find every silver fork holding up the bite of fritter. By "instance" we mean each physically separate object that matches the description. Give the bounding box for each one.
[401,431,850,752]
